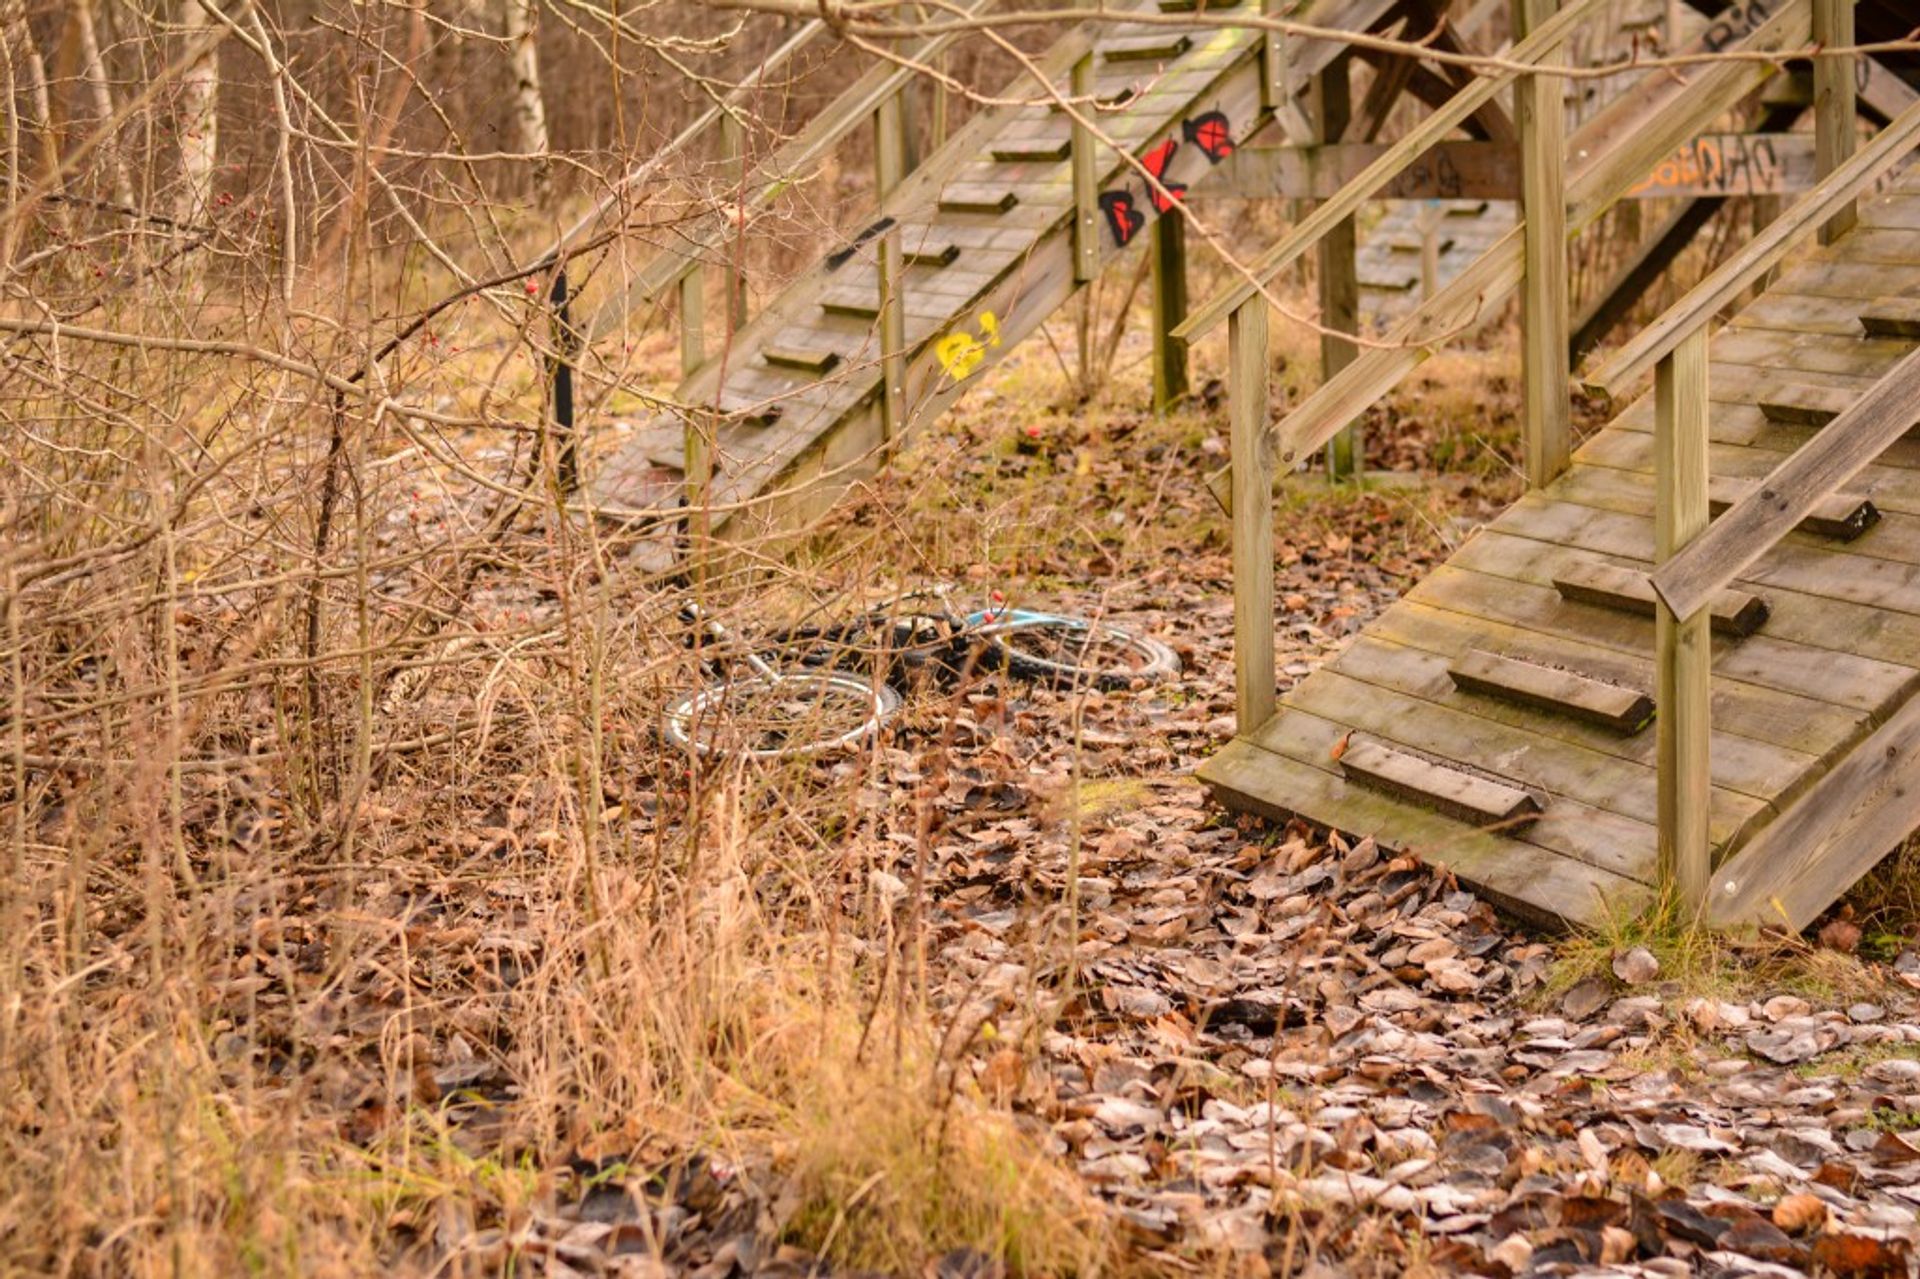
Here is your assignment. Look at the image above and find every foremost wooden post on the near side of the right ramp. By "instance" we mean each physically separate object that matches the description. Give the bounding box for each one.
[1653,328,1713,914]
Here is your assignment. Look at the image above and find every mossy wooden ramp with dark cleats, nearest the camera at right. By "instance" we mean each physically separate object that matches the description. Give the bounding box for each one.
[1200,167,1920,928]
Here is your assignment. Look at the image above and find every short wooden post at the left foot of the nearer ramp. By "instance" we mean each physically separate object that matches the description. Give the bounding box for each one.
[1227,294,1273,736]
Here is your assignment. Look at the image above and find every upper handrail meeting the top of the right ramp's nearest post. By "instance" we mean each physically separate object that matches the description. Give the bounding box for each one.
[1580,94,1920,398]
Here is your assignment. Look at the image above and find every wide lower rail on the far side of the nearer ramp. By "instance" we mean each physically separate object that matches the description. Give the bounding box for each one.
[1277,0,1811,465]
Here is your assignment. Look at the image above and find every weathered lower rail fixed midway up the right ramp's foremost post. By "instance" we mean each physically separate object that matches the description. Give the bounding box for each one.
[1653,343,1920,616]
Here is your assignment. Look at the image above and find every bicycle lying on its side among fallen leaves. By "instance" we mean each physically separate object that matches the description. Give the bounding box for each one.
[662,588,1181,759]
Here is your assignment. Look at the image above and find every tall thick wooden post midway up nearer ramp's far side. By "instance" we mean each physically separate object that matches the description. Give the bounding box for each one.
[1513,0,1572,488]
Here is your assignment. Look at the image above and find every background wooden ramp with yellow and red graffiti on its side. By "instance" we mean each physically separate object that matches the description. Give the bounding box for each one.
[589,0,1396,536]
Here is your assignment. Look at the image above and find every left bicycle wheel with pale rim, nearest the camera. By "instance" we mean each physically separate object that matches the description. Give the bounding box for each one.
[660,670,900,759]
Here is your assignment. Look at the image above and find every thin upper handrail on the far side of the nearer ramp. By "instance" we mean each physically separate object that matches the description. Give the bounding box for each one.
[1173,0,1609,342]
